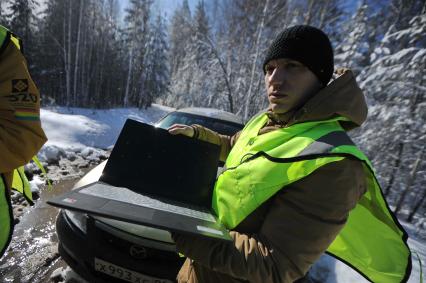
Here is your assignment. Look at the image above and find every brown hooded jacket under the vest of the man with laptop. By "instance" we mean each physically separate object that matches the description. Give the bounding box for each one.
[174,71,367,283]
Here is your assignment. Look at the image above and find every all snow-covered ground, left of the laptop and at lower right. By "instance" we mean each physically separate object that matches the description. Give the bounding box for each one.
[34,105,426,283]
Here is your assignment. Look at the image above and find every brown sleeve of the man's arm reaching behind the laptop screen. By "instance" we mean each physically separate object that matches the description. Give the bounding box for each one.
[191,124,241,161]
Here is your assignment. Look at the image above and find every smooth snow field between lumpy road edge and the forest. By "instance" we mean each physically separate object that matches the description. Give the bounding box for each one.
[41,104,173,149]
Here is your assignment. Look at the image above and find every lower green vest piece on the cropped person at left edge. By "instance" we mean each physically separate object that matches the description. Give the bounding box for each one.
[0,174,13,258]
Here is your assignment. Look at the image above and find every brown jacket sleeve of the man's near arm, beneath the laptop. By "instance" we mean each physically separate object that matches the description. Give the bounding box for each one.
[174,159,366,282]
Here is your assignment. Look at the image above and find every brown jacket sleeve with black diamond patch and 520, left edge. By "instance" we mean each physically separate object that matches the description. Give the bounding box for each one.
[0,41,47,173]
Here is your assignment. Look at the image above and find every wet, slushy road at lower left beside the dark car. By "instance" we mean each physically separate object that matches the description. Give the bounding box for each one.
[0,178,83,283]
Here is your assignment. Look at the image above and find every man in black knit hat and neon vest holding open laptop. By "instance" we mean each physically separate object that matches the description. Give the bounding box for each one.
[169,25,411,283]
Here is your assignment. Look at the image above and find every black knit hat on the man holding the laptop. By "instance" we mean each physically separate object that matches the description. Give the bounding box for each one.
[263,25,334,86]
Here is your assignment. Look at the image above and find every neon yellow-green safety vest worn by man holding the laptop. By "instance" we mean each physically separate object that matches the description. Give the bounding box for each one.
[212,114,411,282]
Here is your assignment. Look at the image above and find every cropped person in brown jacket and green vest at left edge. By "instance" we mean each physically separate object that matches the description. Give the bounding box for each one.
[0,26,47,258]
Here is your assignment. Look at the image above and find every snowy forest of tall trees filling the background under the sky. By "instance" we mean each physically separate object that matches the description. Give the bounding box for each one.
[0,0,426,228]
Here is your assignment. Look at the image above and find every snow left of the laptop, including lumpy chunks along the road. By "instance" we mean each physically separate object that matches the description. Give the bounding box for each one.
[27,104,173,184]
